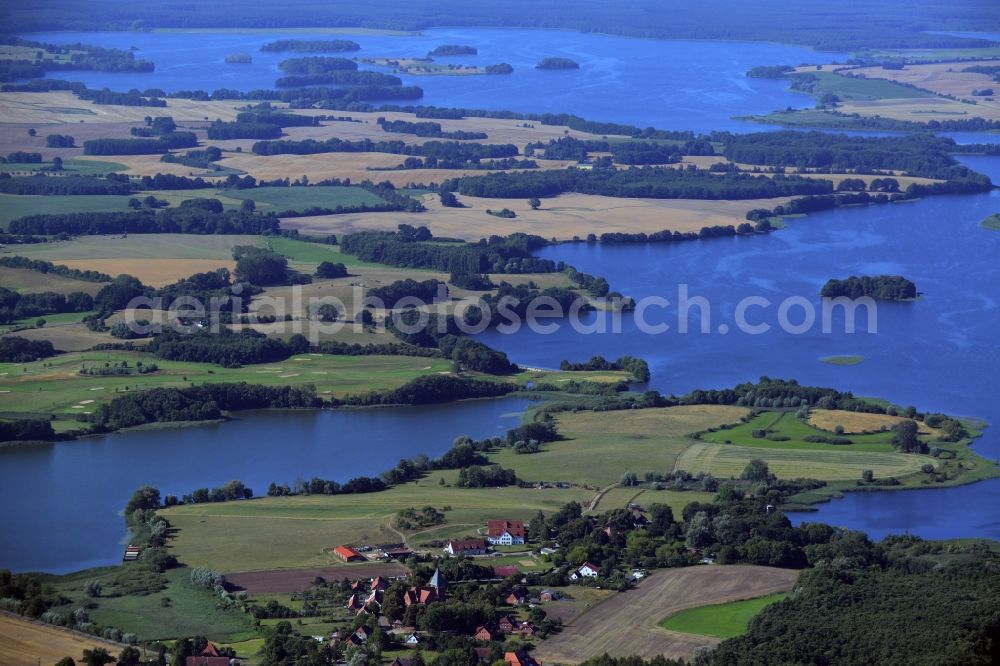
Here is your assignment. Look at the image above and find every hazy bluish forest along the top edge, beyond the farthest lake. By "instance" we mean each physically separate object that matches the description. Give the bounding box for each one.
[7,0,1000,52]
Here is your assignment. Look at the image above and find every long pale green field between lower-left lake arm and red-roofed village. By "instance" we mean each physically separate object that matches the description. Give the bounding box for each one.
[163,478,593,572]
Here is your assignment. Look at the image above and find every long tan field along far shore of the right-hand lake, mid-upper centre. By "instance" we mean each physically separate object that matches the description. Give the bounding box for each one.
[281,194,789,240]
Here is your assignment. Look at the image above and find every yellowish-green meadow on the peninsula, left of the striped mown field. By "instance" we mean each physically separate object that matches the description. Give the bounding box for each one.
[493,405,747,487]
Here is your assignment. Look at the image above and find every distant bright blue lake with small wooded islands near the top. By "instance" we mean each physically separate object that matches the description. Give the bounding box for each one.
[26,28,849,132]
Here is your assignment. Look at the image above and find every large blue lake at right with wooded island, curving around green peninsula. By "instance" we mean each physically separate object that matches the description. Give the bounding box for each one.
[480,157,1000,538]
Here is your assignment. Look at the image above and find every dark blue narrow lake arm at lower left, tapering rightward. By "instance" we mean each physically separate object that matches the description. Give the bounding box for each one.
[0,398,530,573]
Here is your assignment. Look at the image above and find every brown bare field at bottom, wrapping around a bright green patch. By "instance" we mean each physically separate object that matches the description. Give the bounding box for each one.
[533,565,799,664]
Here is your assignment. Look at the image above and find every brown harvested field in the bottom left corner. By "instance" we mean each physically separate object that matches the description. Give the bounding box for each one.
[0,614,131,666]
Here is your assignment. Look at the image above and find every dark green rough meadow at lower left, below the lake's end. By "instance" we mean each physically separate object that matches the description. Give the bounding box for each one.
[41,565,253,641]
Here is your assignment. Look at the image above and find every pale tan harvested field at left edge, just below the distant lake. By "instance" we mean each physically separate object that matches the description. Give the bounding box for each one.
[0,92,243,126]
